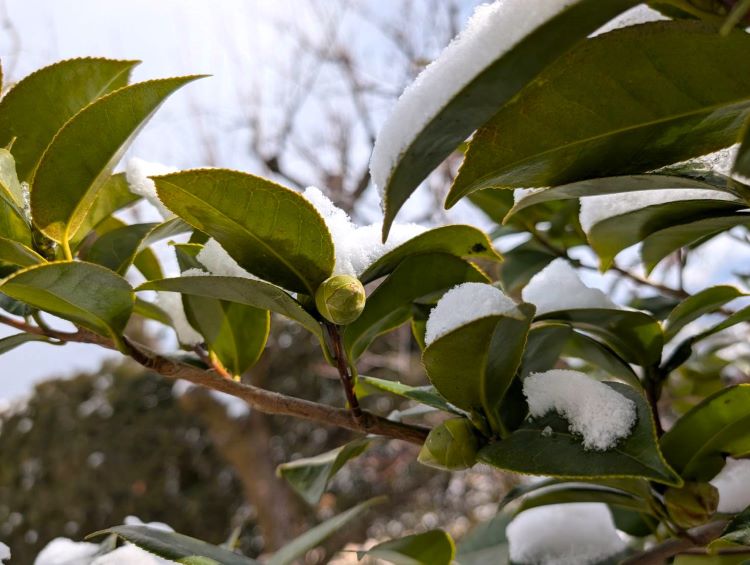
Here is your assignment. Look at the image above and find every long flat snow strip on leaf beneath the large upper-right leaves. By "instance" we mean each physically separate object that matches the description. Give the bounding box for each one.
[580,188,736,234]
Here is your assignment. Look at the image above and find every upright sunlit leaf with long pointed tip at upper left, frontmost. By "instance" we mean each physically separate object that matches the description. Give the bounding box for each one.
[31,76,199,243]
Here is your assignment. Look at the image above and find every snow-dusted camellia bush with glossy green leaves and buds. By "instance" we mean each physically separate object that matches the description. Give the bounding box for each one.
[0,0,750,564]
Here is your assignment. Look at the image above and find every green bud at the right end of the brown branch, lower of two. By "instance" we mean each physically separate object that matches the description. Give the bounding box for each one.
[419,418,479,471]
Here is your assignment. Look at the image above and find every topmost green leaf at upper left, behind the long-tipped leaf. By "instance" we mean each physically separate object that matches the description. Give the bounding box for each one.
[0,58,138,181]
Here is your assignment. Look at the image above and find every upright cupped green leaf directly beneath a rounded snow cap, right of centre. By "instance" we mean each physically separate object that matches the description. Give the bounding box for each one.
[422,304,534,433]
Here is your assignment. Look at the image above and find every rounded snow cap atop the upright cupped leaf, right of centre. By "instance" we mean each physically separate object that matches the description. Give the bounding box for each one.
[425,283,519,345]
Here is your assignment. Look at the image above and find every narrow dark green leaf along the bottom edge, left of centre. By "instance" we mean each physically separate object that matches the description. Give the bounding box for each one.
[88,526,259,565]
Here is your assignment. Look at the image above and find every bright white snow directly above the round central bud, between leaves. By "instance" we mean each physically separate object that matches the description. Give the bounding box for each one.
[303,186,426,276]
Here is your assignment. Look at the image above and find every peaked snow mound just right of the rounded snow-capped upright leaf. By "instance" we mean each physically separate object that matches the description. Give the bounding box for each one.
[521,258,618,315]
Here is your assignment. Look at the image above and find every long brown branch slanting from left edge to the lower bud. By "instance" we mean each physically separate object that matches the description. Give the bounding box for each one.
[0,315,429,445]
